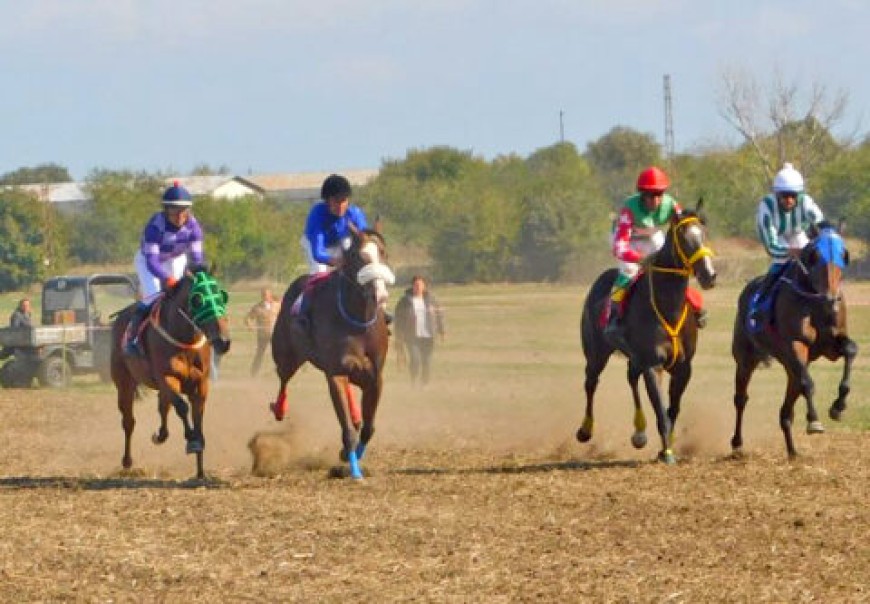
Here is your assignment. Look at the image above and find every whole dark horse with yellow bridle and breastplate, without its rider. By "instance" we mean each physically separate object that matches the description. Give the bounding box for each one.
[577,205,716,464]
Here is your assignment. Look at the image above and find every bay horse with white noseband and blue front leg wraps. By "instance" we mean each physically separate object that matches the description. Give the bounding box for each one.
[271,229,395,479]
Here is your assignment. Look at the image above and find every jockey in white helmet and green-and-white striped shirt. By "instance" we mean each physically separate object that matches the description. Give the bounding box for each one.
[750,163,824,324]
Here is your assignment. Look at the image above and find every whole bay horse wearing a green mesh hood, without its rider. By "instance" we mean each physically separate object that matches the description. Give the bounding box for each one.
[111,267,230,480]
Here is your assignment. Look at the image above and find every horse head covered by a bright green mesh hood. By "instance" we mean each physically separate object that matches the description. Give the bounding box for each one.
[172,267,231,355]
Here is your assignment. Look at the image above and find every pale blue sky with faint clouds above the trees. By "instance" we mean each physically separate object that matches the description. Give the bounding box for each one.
[0,0,870,178]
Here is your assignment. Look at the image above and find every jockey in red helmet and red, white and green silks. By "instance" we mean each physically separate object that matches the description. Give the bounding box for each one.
[604,166,706,336]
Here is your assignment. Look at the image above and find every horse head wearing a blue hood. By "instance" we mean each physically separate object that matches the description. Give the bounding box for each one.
[798,221,849,321]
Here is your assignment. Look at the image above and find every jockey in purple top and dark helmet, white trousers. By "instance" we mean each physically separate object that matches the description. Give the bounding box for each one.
[125,181,203,355]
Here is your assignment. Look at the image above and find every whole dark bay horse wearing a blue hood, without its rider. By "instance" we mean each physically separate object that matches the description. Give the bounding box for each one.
[731,222,858,458]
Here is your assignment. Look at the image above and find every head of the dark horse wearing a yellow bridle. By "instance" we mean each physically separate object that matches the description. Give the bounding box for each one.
[662,199,716,289]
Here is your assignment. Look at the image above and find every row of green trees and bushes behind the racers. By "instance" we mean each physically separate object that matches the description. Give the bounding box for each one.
[0,118,870,291]
